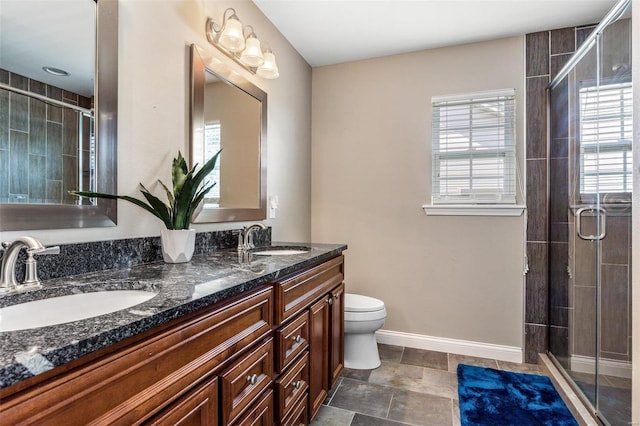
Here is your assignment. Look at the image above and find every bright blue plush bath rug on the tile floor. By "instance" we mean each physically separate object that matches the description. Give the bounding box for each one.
[458,364,578,426]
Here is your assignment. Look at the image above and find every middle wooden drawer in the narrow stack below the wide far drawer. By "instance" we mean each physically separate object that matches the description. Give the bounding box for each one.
[276,352,309,420]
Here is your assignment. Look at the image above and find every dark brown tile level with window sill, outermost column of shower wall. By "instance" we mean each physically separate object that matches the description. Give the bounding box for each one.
[527,159,547,241]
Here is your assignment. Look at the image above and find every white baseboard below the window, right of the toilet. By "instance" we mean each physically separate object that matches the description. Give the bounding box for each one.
[376,330,522,363]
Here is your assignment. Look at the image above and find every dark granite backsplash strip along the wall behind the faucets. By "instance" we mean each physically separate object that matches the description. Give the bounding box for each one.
[0,227,271,282]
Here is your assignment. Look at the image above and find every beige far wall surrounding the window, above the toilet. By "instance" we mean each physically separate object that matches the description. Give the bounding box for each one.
[311,37,524,347]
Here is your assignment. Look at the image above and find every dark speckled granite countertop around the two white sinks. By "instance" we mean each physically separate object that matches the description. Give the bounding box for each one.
[0,243,347,388]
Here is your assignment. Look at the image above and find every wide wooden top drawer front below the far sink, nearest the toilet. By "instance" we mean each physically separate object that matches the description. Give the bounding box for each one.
[275,255,344,325]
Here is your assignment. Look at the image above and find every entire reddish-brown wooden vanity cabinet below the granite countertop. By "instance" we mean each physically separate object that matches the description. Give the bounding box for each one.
[0,251,344,426]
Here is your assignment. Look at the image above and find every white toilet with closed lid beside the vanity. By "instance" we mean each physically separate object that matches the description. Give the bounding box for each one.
[344,293,387,370]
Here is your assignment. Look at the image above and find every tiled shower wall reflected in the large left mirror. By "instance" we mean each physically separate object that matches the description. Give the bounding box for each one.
[0,68,92,204]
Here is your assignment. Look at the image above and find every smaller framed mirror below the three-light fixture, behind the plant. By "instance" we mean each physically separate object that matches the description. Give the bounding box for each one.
[189,45,267,223]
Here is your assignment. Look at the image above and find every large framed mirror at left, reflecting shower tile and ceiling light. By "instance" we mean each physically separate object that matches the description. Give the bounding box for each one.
[0,0,118,231]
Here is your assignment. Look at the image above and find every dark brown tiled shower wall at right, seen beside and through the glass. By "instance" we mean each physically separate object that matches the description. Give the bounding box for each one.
[525,21,631,363]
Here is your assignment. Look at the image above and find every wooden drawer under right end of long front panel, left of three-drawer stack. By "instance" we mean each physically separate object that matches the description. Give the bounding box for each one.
[220,338,273,425]
